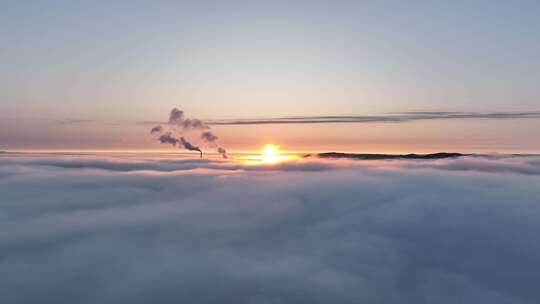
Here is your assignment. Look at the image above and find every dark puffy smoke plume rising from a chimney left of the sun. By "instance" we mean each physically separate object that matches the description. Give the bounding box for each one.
[150,108,227,158]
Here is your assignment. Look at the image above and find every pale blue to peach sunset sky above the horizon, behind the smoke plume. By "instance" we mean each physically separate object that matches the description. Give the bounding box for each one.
[0,1,540,152]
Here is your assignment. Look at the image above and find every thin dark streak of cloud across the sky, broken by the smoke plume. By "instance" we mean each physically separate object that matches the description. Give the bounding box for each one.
[138,111,540,125]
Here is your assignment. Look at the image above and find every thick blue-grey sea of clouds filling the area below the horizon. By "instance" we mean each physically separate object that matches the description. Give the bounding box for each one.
[0,153,540,304]
